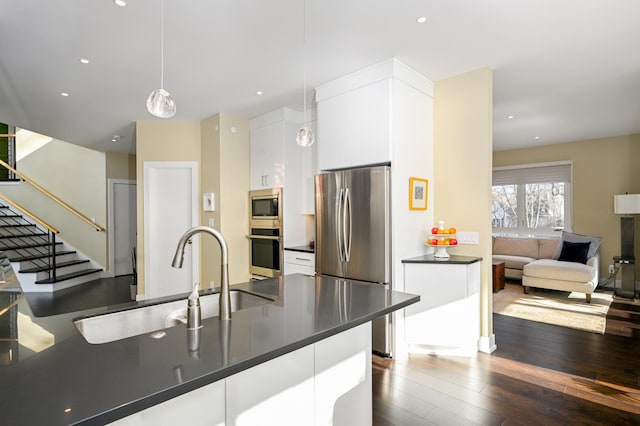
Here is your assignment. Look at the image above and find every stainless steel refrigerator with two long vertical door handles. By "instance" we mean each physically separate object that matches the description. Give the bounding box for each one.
[315,166,392,356]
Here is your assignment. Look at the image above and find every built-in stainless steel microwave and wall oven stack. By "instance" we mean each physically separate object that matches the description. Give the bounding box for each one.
[248,188,283,278]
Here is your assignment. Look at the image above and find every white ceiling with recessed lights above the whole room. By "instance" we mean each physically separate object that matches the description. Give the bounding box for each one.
[0,0,640,152]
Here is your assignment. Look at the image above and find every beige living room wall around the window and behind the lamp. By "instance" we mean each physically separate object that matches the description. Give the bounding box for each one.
[493,134,640,279]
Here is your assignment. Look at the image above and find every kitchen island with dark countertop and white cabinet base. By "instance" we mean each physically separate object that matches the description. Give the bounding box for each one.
[0,268,419,425]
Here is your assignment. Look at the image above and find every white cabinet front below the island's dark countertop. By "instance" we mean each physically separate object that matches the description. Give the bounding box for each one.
[112,322,373,426]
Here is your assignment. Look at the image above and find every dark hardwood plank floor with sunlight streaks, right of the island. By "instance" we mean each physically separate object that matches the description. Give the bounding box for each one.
[373,301,640,425]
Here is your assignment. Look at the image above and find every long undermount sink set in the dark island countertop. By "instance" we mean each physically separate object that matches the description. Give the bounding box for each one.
[73,289,274,344]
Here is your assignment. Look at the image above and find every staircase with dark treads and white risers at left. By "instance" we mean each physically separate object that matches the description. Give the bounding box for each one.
[0,203,102,292]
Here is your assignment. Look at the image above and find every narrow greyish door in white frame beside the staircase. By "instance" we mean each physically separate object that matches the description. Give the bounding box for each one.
[109,179,136,276]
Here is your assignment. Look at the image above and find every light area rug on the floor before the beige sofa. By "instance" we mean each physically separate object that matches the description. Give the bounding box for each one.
[493,283,613,334]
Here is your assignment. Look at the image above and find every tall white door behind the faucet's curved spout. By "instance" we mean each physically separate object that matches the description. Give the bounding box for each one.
[144,161,199,299]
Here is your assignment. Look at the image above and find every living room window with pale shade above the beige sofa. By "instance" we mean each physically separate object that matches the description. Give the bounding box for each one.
[491,162,571,235]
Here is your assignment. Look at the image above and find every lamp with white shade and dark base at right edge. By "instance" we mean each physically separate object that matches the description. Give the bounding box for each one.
[613,194,640,298]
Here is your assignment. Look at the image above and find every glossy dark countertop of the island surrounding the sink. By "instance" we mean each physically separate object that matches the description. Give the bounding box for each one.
[0,264,419,425]
